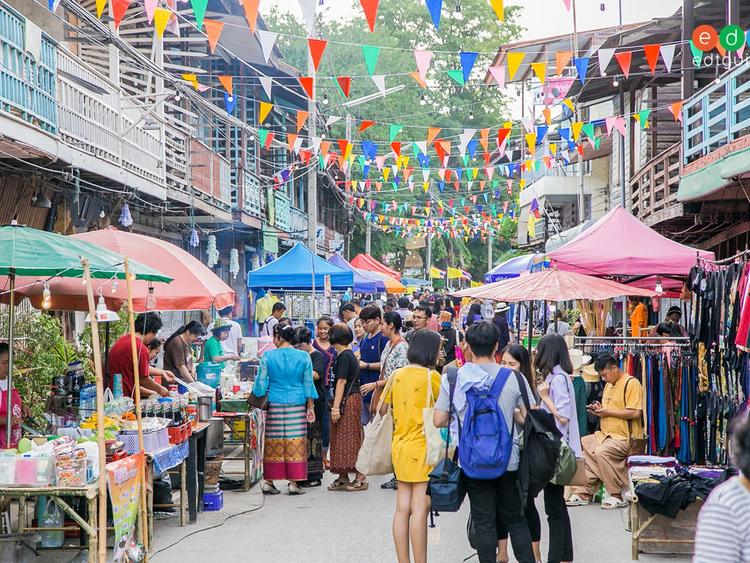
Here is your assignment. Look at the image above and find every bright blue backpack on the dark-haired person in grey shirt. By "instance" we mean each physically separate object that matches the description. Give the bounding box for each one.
[458,368,513,479]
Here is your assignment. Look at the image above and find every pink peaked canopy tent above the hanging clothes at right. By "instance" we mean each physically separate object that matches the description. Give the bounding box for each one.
[549,205,714,280]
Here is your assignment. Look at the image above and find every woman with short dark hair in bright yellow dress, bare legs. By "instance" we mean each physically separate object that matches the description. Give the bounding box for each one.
[385,329,442,563]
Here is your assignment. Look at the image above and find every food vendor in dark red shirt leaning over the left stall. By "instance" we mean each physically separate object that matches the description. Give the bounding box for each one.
[107,313,169,398]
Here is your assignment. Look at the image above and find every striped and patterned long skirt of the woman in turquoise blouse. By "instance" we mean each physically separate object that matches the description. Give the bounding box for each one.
[263,403,307,481]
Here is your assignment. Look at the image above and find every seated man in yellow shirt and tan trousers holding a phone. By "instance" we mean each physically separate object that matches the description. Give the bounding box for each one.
[567,354,643,510]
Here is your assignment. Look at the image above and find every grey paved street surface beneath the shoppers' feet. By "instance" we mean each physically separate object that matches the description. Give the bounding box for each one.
[152,477,689,563]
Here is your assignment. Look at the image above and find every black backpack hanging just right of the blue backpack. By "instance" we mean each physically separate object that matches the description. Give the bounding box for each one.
[515,372,562,509]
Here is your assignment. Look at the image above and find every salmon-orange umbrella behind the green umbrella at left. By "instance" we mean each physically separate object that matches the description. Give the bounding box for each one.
[18,227,235,312]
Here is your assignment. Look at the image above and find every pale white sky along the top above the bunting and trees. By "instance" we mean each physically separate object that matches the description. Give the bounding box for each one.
[260,0,682,41]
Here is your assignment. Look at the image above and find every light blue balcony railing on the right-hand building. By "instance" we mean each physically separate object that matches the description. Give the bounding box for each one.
[682,61,750,164]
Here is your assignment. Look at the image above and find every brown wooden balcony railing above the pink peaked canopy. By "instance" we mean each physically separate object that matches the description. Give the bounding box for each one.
[630,142,682,225]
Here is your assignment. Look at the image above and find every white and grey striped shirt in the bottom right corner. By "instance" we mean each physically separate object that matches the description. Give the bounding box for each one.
[693,477,750,563]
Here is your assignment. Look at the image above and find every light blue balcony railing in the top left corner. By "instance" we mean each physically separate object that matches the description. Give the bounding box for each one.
[0,3,57,133]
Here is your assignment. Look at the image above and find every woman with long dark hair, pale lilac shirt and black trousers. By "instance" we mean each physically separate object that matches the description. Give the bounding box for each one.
[527,334,583,563]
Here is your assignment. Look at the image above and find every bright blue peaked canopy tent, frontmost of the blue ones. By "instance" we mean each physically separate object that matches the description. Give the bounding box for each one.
[247,242,354,291]
